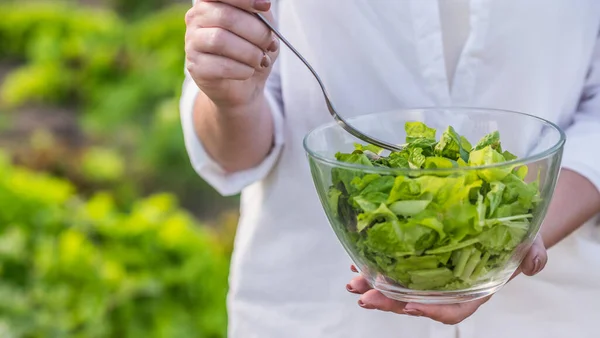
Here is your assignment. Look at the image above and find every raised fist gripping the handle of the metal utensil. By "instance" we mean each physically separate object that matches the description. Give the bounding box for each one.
[185,0,279,107]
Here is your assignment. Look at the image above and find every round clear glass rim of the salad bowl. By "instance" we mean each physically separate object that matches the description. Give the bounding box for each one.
[302,106,567,174]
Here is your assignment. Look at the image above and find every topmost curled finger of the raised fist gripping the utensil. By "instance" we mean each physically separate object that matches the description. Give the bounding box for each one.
[194,2,279,52]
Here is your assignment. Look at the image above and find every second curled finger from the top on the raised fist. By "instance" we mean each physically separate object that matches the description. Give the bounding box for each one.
[186,28,271,69]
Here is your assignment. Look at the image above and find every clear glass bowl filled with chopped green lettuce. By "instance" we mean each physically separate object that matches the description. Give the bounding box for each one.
[304,108,565,304]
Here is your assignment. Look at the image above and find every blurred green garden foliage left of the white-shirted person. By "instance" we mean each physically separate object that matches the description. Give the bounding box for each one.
[0,0,237,338]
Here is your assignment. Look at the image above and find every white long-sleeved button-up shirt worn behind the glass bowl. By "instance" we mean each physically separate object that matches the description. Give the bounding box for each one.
[181,0,600,338]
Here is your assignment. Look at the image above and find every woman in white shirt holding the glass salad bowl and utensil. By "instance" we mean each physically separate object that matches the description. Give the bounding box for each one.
[181,0,600,338]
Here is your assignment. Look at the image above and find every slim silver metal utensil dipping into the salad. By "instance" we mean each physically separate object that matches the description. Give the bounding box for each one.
[255,13,402,151]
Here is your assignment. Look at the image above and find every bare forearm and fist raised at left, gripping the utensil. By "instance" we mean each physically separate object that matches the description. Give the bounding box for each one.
[186,0,278,173]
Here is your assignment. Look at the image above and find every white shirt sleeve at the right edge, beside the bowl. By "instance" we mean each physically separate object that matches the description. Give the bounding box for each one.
[562,33,600,194]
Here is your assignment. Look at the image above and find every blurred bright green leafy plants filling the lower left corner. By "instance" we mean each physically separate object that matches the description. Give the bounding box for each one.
[0,153,230,338]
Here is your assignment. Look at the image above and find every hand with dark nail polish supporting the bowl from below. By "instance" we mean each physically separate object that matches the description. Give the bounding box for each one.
[346,236,548,325]
